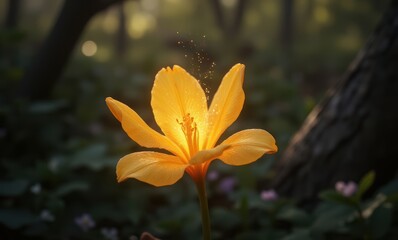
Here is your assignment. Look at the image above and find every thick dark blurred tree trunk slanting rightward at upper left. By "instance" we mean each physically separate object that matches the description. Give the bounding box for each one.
[19,0,124,100]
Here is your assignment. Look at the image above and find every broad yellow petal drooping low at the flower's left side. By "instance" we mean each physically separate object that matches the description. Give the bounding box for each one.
[116,152,187,187]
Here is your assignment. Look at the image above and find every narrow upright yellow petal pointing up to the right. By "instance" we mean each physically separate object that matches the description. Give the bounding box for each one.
[204,63,245,149]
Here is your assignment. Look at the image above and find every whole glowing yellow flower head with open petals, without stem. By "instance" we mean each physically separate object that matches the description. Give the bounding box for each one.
[106,64,277,186]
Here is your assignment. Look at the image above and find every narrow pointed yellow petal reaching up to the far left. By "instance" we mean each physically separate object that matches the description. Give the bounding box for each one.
[106,97,183,156]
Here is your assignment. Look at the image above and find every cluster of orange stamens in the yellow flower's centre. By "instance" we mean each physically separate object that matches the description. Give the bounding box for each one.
[177,113,199,156]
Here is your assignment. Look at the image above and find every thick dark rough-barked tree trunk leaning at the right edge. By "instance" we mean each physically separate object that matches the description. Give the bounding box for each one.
[273,1,398,204]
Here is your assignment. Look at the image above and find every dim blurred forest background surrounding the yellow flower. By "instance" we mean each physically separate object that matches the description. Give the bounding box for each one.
[0,0,398,239]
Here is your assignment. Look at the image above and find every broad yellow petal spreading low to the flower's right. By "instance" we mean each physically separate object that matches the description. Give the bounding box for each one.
[218,129,278,166]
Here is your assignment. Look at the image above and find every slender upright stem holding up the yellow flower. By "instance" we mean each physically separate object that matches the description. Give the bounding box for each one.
[195,177,211,240]
